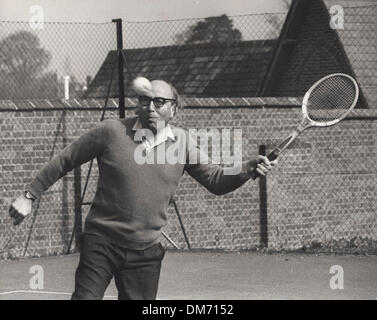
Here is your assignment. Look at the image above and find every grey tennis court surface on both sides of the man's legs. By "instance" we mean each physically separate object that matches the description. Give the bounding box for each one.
[0,250,377,300]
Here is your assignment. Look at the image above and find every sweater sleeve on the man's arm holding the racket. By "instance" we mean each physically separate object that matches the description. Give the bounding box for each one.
[185,130,249,195]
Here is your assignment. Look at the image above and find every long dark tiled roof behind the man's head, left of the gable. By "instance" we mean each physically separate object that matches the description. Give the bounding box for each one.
[86,40,275,98]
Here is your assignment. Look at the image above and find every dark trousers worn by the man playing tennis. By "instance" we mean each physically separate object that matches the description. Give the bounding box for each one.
[72,234,165,300]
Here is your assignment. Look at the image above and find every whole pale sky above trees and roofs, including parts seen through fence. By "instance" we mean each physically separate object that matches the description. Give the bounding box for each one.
[0,0,289,86]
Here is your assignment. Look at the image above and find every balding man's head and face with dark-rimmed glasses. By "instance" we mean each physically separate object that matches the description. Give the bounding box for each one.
[137,80,175,133]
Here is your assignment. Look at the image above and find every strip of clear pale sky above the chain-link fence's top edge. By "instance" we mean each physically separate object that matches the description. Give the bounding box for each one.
[0,0,286,22]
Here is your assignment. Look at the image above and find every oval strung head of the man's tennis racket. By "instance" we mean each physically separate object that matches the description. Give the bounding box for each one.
[307,75,357,122]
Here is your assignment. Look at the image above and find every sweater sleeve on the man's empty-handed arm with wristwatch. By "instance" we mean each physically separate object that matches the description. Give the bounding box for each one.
[26,120,108,198]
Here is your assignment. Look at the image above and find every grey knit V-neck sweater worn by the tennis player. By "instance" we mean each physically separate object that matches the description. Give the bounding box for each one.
[27,117,248,249]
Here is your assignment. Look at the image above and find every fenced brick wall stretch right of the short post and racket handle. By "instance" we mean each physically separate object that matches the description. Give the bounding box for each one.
[262,116,377,253]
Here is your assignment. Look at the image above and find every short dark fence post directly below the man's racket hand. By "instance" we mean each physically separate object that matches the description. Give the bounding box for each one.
[259,145,268,248]
